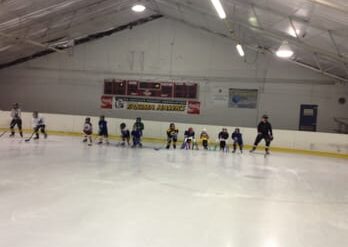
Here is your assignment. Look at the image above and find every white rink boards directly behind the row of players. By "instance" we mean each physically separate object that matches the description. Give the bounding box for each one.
[0,111,348,155]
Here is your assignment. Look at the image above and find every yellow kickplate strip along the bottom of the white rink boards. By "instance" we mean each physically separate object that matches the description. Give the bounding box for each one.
[0,129,348,159]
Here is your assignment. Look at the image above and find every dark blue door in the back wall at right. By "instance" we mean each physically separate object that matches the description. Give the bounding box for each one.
[299,105,318,131]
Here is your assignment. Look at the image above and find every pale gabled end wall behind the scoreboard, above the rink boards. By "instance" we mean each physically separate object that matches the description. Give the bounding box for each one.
[0,18,348,132]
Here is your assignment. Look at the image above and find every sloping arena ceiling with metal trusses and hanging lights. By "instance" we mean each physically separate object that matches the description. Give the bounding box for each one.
[0,0,348,82]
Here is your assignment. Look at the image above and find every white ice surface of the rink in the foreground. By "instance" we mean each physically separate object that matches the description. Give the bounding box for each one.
[0,136,348,247]
